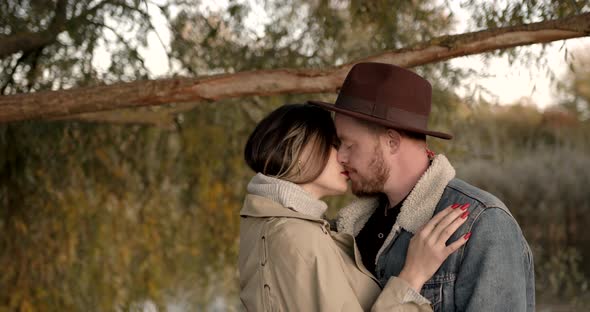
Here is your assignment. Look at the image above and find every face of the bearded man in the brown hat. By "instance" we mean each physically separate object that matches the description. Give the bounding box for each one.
[334,114,389,196]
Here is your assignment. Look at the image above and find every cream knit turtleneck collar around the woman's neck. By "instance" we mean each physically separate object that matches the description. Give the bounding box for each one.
[247,173,328,218]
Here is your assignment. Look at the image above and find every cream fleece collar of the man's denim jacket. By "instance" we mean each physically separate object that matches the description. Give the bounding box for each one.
[336,155,455,236]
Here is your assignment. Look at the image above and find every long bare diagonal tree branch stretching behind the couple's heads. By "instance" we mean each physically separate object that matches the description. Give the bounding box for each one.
[0,13,590,122]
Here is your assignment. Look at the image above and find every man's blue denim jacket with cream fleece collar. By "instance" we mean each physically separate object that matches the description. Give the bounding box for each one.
[337,155,535,311]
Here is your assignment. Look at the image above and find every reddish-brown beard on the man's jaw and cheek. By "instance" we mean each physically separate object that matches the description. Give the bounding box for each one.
[351,144,389,196]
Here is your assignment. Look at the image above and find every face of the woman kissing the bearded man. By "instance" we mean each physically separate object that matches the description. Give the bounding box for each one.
[303,147,349,198]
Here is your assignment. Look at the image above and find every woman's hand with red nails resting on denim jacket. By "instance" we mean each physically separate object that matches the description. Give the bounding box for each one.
[398,204,471,292]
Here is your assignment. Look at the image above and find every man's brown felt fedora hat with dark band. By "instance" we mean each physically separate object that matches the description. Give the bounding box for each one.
[308,63,453,140]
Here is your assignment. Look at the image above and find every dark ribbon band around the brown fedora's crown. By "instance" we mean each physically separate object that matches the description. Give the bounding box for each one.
[335,93,428,130]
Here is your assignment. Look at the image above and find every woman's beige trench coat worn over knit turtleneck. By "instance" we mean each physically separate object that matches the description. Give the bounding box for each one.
[239,194,432,312]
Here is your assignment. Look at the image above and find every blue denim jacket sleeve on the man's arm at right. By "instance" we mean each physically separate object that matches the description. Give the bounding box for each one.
[455,208,534,311]
